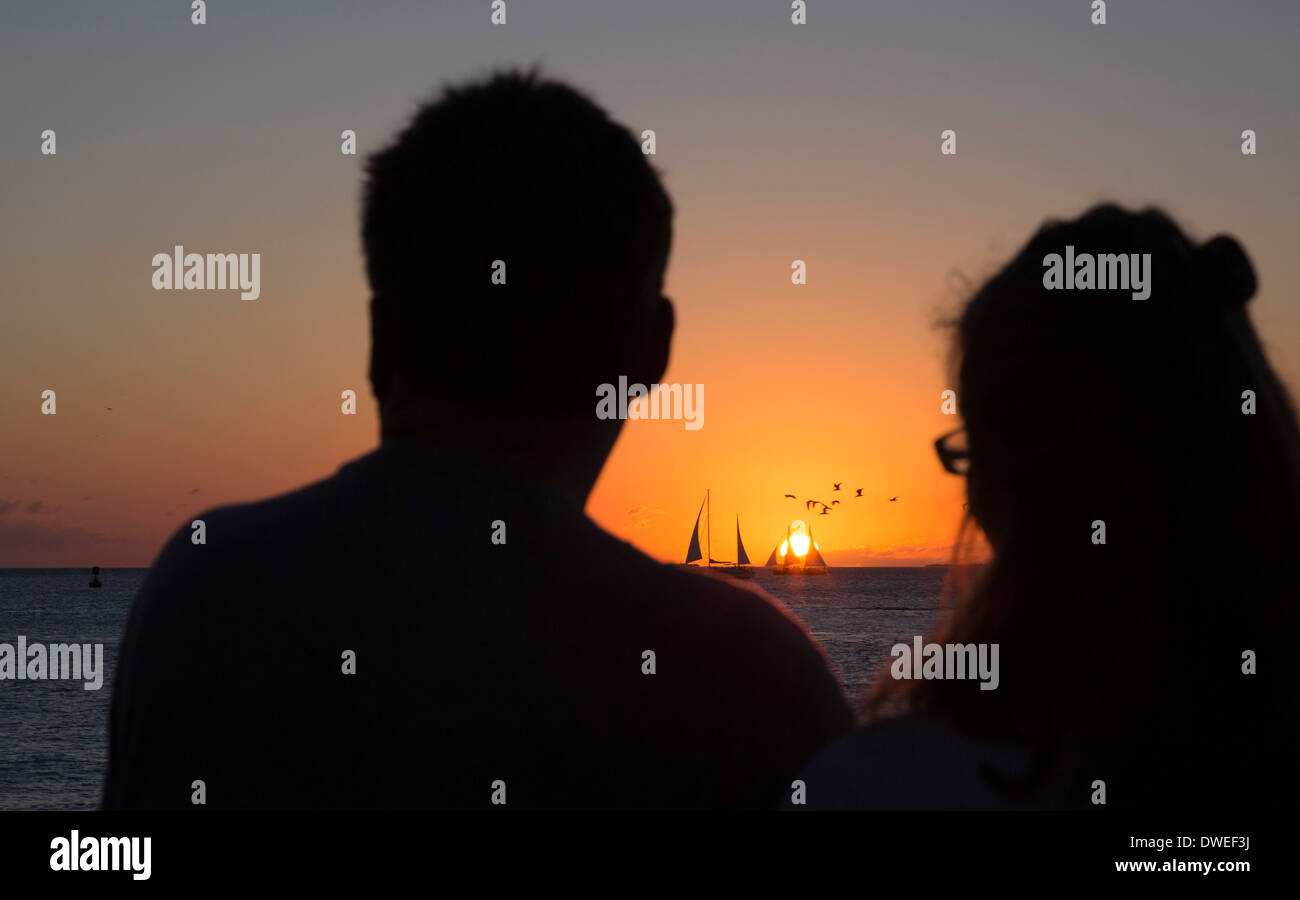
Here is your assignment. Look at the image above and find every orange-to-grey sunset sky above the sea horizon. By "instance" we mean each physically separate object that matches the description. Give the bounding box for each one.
[0,0,1300,567]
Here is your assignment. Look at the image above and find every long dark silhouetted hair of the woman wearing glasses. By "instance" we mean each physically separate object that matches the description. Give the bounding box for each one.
[868,205,1300,808]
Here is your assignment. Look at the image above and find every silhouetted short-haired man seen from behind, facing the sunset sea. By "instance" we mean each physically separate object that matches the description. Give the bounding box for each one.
[104,74,852,808]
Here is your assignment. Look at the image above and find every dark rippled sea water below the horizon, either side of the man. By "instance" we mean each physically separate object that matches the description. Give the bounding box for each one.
[0,567,946,810]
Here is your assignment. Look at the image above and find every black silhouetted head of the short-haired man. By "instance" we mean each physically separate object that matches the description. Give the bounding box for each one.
[361,73,672,491]
